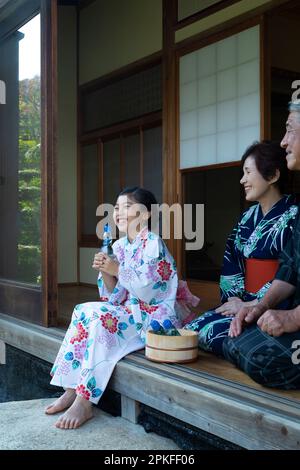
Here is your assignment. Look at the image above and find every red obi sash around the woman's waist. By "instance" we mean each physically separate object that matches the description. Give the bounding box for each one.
[245,258,279,293]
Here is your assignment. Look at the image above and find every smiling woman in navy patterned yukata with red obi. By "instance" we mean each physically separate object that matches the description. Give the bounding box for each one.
[185,142,298,356]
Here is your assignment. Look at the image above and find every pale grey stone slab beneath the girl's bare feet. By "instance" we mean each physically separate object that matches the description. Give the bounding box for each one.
[0,399,179,450]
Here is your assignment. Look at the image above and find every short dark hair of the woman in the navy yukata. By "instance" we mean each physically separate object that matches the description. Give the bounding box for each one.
[241,140,288,193]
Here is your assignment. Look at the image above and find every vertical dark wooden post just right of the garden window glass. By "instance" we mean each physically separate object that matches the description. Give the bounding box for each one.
[41,0,58,326]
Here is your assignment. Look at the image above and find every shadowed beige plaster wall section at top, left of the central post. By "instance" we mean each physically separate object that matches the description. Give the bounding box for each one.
[79,0,162,84]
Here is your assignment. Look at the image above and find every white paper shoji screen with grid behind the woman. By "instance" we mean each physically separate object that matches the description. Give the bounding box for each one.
[180,26,260,169]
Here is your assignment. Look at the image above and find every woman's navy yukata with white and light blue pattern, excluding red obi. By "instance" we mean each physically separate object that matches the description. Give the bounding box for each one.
[185,195,298,356]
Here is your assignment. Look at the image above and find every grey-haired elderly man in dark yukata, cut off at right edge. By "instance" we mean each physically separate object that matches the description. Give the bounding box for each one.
[223,100,300,389]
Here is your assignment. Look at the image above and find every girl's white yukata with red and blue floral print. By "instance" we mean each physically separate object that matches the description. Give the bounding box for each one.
[51,229,181,403]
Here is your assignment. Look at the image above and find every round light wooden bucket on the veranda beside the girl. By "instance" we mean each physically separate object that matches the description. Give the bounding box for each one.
[145,329,198,363]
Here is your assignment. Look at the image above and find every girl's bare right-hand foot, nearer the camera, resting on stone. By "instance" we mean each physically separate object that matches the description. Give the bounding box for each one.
[55,395,93,429]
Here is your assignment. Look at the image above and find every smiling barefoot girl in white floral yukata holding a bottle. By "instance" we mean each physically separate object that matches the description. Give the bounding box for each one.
[46,187,181,429]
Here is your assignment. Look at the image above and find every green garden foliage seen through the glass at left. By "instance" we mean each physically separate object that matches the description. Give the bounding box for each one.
[18,77,41,284]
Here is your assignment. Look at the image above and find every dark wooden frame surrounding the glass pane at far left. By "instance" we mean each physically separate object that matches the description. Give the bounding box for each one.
[0,0,57,326]
